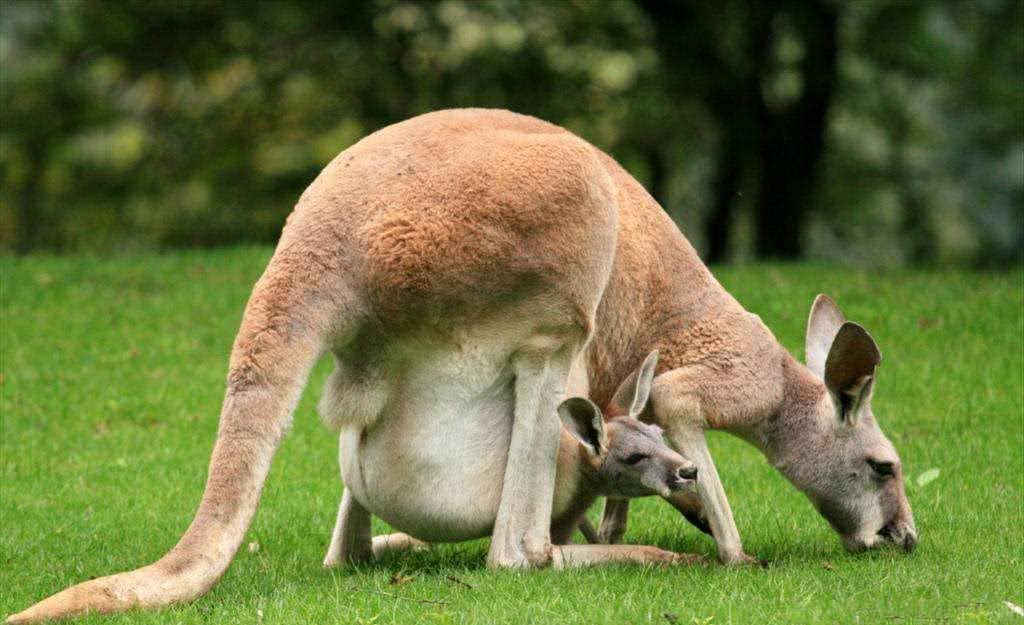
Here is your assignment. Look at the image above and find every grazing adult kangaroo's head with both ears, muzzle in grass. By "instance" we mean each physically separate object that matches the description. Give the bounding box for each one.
[775,295,918,551]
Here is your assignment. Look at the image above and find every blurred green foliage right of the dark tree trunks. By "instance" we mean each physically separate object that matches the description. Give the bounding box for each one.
[810,0,1024,265]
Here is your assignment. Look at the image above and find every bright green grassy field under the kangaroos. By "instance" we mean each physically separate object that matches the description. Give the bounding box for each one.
[0,248,1024,625]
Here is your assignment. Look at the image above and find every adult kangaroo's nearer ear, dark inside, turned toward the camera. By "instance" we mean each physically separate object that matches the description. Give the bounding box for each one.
[824,322,882,425]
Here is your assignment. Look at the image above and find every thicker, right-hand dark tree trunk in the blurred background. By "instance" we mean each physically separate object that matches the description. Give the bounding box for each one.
[755,1,839,259]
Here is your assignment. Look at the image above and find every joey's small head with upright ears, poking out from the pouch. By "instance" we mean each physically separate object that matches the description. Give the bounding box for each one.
[558,351,697,498]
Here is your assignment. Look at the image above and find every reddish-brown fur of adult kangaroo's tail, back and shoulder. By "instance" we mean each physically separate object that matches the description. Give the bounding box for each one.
[9,110,909,622]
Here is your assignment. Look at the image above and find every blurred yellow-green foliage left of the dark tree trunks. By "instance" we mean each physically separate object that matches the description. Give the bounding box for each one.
[0,0,655,251]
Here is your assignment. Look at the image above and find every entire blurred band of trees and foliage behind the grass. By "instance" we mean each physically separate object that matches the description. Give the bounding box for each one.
[0,0,1024,264]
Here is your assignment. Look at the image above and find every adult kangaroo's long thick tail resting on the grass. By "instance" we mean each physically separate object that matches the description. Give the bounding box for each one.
[7,248,345,623]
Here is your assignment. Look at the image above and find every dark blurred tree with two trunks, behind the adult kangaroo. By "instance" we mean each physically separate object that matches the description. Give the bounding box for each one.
[639,0,839,262]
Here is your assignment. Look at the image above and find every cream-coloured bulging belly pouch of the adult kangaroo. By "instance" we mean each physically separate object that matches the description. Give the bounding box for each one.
[321,318,586,542]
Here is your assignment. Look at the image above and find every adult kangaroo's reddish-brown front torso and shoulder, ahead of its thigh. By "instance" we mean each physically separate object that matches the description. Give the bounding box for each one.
[587,153,790,432]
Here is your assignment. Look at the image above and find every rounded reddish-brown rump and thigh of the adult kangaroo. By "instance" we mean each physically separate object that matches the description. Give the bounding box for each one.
[288,111,615,330]
